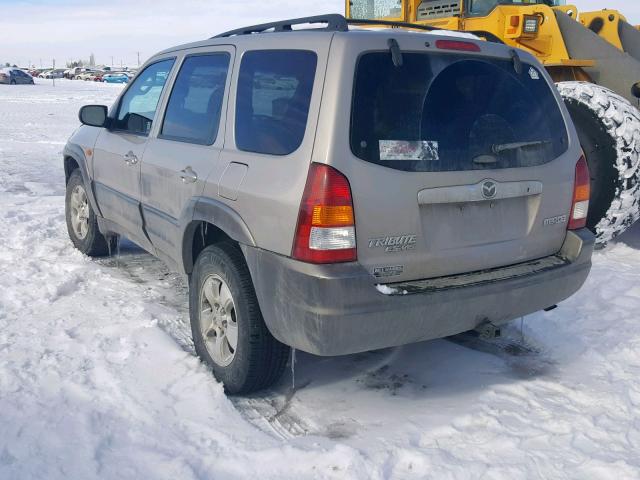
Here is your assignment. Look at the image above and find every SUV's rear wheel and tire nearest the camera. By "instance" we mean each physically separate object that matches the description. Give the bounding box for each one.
[189,242,289,394]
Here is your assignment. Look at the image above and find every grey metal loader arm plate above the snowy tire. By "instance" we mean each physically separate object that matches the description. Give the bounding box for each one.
[555,10,640,106]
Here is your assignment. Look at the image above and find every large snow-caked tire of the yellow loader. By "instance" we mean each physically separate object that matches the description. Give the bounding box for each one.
[557,82,640,246]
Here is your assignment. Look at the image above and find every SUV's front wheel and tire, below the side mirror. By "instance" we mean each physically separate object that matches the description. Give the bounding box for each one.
[65,169,115,257]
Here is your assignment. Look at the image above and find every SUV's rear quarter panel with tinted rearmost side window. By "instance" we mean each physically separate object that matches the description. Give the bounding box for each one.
[214,43,324,255]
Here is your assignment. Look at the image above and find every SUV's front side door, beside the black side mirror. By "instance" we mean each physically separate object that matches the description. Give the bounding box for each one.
[93,58,174,247]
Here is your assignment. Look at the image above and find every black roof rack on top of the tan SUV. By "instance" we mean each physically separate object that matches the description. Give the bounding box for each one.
[211,13,504,43]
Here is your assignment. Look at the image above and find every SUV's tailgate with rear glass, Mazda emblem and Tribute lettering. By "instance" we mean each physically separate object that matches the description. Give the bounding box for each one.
[325,41,579,282]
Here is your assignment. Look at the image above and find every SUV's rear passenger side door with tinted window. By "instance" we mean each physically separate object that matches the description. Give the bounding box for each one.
[142,46,234,258]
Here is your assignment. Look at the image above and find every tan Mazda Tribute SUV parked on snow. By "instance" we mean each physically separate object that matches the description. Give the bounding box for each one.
[64,15,594,393]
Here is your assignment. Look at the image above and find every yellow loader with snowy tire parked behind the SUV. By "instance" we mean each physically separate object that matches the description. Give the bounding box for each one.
[346,0,640,240]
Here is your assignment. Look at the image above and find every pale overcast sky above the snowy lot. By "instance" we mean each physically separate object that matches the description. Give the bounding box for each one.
[0,0,640,67]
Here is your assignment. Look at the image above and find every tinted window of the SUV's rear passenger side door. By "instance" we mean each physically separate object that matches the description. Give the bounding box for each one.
[160,52,231,145]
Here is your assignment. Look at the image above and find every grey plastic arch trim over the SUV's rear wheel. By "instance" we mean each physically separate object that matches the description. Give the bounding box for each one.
[180,197,256,273]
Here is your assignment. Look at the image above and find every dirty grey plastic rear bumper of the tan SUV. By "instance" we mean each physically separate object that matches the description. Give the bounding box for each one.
[243,229,595,356]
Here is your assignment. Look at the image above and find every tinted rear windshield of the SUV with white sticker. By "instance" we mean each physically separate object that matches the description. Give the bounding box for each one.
[351,52,568,172]
